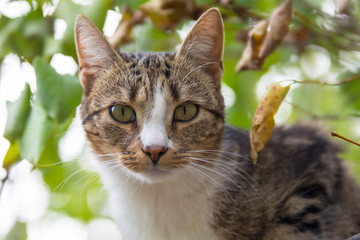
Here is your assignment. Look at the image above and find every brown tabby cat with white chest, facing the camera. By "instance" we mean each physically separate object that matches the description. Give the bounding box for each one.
[75,8,360,240]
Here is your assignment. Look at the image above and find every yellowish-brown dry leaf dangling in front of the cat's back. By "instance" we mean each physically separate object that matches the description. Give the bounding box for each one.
[250,83,290,163]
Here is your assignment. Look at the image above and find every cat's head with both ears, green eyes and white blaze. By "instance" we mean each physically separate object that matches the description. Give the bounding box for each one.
[75,8,224,182]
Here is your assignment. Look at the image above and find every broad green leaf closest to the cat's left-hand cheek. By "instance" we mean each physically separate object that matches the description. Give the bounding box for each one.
[33,58,82,122]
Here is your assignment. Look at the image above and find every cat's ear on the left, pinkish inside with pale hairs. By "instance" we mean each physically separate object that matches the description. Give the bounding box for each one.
[75,14,118,95]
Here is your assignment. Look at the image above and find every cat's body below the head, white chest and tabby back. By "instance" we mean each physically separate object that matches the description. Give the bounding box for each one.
[100,125,360,240]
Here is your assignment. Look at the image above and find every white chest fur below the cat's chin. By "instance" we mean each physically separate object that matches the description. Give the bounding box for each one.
[100,163,217,240]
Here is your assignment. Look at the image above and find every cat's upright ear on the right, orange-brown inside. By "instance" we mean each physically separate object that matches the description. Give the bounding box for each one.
[175,8,224,83]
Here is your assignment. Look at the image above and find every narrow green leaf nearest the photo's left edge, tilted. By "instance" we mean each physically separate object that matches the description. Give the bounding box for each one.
[4,84,31,143]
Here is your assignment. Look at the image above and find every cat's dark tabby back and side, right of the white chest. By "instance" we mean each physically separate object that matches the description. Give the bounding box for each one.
[217,124,360,239]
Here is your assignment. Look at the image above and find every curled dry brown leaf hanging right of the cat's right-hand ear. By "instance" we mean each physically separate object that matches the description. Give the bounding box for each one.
[235,0,292,72]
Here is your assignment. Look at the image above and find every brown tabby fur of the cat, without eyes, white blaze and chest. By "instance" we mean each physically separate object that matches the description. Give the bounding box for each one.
[76,9,360,240]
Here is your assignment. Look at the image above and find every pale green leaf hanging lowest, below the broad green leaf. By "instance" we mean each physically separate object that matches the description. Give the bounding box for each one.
[20,102,54,164]
